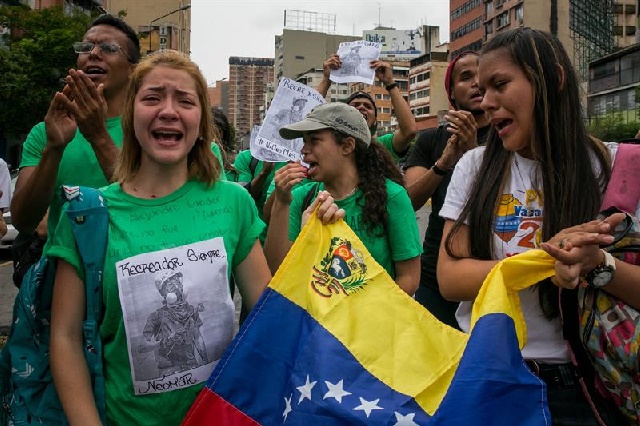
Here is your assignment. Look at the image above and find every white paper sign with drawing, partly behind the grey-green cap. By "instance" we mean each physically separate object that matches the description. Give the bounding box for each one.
[250,78,324,162]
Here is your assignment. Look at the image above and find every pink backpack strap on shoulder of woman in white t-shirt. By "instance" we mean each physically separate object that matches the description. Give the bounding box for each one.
[600,143,640,216]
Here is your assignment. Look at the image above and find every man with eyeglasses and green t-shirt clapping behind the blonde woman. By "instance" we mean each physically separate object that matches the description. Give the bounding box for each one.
[11,15,140,254]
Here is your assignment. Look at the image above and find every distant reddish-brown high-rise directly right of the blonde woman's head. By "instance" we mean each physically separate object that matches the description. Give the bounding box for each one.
[227,56,273,143]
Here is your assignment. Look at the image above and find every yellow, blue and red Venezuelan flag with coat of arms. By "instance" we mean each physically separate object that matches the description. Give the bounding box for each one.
[183,215,553,426]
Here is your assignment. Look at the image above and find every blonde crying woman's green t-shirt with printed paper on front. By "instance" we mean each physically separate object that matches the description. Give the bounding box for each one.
[49,181,264,425]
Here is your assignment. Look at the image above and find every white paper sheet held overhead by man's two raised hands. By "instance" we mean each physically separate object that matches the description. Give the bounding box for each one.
[329,40,381,84]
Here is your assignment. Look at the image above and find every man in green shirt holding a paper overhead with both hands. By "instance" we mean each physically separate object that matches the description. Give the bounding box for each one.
[316,54,416,163]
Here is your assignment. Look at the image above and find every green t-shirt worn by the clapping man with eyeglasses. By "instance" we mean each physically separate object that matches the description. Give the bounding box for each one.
[20,117,122,253]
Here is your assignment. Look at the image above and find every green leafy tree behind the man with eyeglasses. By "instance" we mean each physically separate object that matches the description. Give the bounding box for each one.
[0,6,92,134]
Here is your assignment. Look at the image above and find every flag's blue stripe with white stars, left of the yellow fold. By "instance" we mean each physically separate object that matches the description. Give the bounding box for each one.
[207,288,429,426]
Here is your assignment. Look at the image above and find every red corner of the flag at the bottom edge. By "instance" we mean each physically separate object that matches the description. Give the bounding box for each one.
[182,387,259,426]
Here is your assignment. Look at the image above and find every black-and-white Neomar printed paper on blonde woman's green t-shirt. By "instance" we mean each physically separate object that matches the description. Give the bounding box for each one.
[116,238,235,395]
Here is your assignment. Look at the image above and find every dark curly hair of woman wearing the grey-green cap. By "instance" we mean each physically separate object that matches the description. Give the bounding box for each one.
[334,130,404,236]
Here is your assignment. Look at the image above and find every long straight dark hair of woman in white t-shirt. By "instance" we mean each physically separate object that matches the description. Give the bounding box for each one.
[445,28,610,319]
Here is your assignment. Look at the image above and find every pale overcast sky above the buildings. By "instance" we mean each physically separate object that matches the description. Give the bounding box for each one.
[191,0,449,85]
